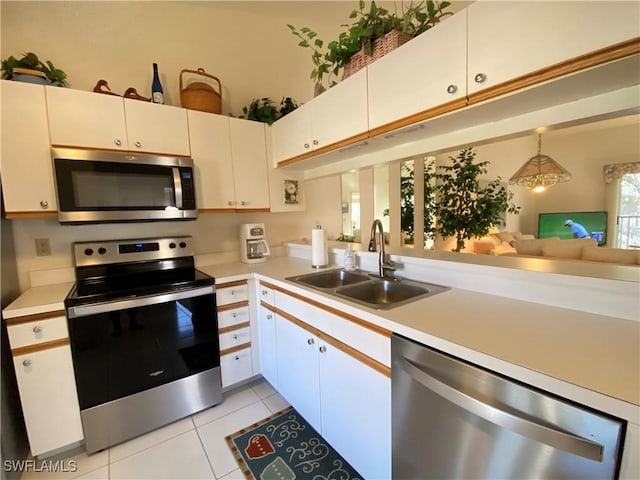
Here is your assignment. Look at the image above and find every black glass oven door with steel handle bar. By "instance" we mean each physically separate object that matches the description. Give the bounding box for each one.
[67,286,220,410]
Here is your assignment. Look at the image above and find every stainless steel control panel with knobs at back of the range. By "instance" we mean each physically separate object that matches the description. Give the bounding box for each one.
[73,236,193,267]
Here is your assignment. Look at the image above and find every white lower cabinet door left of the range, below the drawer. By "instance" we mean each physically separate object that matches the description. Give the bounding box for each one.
[13,345,84,456]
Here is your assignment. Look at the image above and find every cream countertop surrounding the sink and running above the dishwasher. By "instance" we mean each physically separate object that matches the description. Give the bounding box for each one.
[201,257,640,421]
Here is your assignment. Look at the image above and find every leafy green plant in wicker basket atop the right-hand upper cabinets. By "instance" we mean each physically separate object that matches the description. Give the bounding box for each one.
[287,0,452,93]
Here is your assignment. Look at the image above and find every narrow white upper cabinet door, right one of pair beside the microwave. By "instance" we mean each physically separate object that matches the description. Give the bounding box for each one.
[227,118,269,210]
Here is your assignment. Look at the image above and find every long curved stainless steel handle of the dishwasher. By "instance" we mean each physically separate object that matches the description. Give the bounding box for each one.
[396,357,604,462]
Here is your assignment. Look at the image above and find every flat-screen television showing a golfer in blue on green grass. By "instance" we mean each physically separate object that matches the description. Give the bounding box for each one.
[538,212,607,245]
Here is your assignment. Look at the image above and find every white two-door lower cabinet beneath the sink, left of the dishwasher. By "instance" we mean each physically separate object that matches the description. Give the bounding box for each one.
[268,286,391,479]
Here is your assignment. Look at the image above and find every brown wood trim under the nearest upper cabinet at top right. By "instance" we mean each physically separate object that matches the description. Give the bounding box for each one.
[468,37,640,105]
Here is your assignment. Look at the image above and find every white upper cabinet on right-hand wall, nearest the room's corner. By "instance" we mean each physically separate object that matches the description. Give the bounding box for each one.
[272,69,369,164]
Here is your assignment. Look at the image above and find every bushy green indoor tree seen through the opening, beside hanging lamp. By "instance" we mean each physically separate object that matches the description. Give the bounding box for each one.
[435,148,520,252]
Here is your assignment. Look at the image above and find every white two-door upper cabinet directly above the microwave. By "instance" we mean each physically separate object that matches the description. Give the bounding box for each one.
[46,87,190,156]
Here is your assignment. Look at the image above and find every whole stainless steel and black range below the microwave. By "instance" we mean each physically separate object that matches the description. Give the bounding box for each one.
[65,237,222,453]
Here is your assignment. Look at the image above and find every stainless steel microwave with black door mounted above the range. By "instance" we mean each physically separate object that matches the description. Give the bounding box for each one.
[52,148,198,223]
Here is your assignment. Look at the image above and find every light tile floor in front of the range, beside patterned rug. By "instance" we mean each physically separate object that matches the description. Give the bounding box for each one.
[21,380,289,480]
